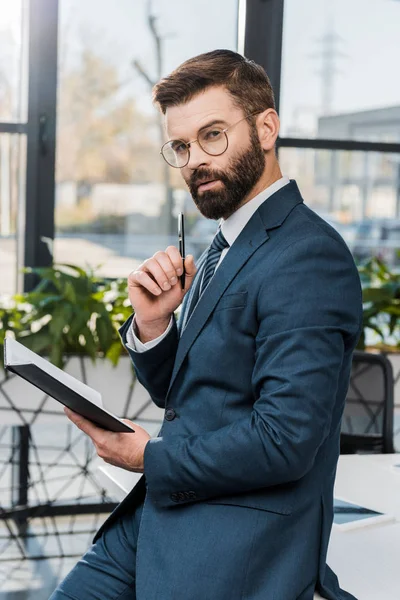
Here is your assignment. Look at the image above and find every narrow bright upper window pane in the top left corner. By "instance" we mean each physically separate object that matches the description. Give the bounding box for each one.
[0,0,28,123]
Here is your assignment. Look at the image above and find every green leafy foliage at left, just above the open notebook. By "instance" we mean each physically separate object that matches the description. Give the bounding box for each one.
[2,264,132,368]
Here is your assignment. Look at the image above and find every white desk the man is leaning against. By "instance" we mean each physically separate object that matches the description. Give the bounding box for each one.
[99,454,400,600]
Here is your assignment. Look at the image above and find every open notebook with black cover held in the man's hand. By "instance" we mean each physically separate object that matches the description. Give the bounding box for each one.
[4,338,134,432]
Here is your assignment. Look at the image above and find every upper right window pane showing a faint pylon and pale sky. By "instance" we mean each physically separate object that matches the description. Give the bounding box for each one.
[280,0,400,142]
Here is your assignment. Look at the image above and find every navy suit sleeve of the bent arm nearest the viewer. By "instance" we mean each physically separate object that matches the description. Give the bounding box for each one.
[144,236,362,507]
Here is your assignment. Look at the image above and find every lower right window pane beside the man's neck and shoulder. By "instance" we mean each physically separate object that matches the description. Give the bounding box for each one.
[279,148,400,268]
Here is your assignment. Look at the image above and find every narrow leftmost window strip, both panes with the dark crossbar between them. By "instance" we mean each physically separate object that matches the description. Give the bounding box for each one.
[0,0,28,295]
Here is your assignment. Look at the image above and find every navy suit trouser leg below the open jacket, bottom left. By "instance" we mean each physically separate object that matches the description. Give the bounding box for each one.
[49,504,143,600]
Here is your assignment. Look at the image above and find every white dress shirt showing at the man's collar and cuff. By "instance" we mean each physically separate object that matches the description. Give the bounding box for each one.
[126,177,289,352]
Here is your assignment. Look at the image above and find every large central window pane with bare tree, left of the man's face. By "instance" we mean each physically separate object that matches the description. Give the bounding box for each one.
[54,0,238,277]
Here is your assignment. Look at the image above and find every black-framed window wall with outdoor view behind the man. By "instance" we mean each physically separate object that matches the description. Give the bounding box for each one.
[0,0,400,293]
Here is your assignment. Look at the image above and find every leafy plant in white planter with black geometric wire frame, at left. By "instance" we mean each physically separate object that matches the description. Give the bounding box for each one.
[0,264,162,548]
